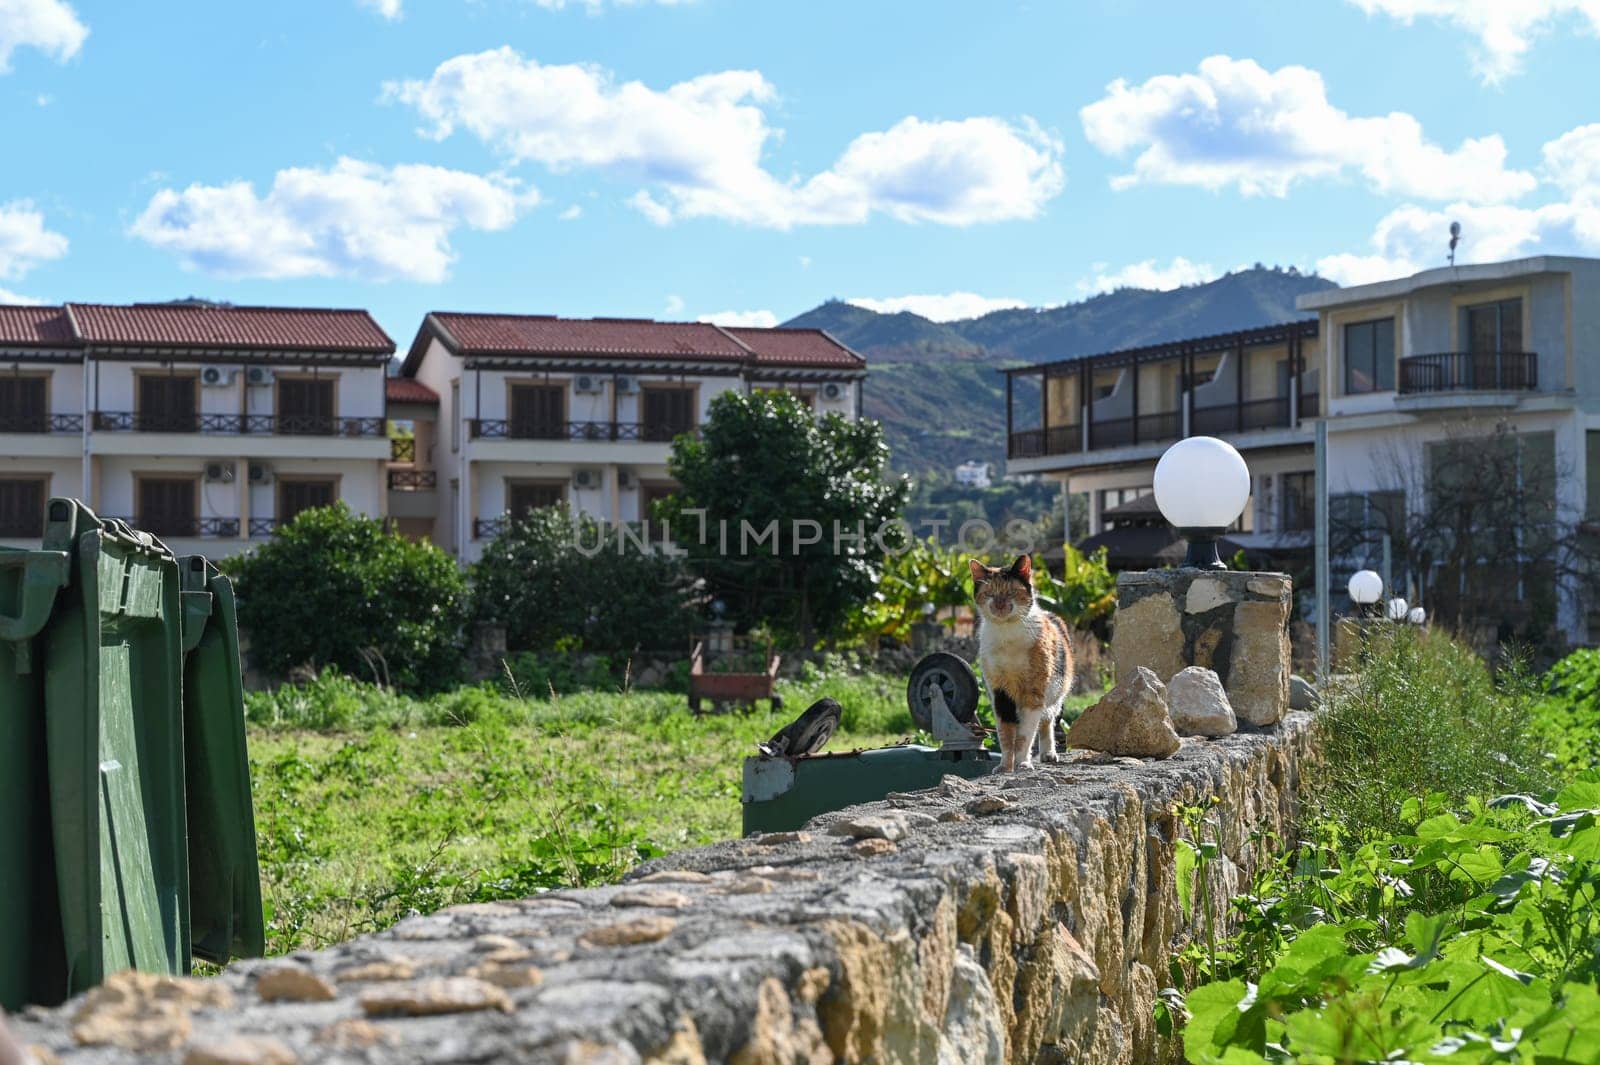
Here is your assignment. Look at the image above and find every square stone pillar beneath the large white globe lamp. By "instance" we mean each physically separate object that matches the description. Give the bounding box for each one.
[1110,569,1293,726]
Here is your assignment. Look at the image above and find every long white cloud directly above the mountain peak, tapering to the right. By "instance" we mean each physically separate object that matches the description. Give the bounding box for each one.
[1078,56,1536,203]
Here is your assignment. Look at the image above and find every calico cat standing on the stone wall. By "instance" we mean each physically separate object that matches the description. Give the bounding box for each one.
[970,555,1072,772]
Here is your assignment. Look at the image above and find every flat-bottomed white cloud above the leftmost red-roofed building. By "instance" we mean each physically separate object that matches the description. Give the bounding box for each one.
[131,158,538,281]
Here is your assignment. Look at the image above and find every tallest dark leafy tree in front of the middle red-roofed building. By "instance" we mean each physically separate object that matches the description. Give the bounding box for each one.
[658,392,910,648]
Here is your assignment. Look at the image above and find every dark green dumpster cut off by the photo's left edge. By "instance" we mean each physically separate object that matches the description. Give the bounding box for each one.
[0,548,67,1009]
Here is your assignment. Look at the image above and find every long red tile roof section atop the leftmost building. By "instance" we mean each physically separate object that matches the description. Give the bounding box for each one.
[67,304,395,355]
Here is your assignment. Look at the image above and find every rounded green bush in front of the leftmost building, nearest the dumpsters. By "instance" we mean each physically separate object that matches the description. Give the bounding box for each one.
[224,504,466,691]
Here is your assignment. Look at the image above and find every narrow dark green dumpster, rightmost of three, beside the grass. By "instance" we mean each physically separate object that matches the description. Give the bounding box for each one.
[178,555,266,963]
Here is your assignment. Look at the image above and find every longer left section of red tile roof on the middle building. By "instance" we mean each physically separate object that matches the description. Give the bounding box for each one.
[430,312,750,361]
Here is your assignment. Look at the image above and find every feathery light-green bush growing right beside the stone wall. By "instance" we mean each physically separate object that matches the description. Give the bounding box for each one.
[1310,625,1547,838]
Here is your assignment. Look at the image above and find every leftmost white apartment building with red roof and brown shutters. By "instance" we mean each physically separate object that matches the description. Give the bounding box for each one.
[0,304,395,556]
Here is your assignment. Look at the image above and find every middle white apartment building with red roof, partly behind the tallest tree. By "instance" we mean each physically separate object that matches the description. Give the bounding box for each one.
[400,312,866,561]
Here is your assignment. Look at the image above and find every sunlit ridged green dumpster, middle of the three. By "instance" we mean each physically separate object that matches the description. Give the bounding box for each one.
[45,499,189,993]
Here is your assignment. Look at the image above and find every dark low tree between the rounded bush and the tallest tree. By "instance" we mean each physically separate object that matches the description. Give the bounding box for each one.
[472,505,696,651]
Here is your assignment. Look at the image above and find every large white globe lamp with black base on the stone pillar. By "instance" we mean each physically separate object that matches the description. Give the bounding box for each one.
[1155,437,1250,569]
